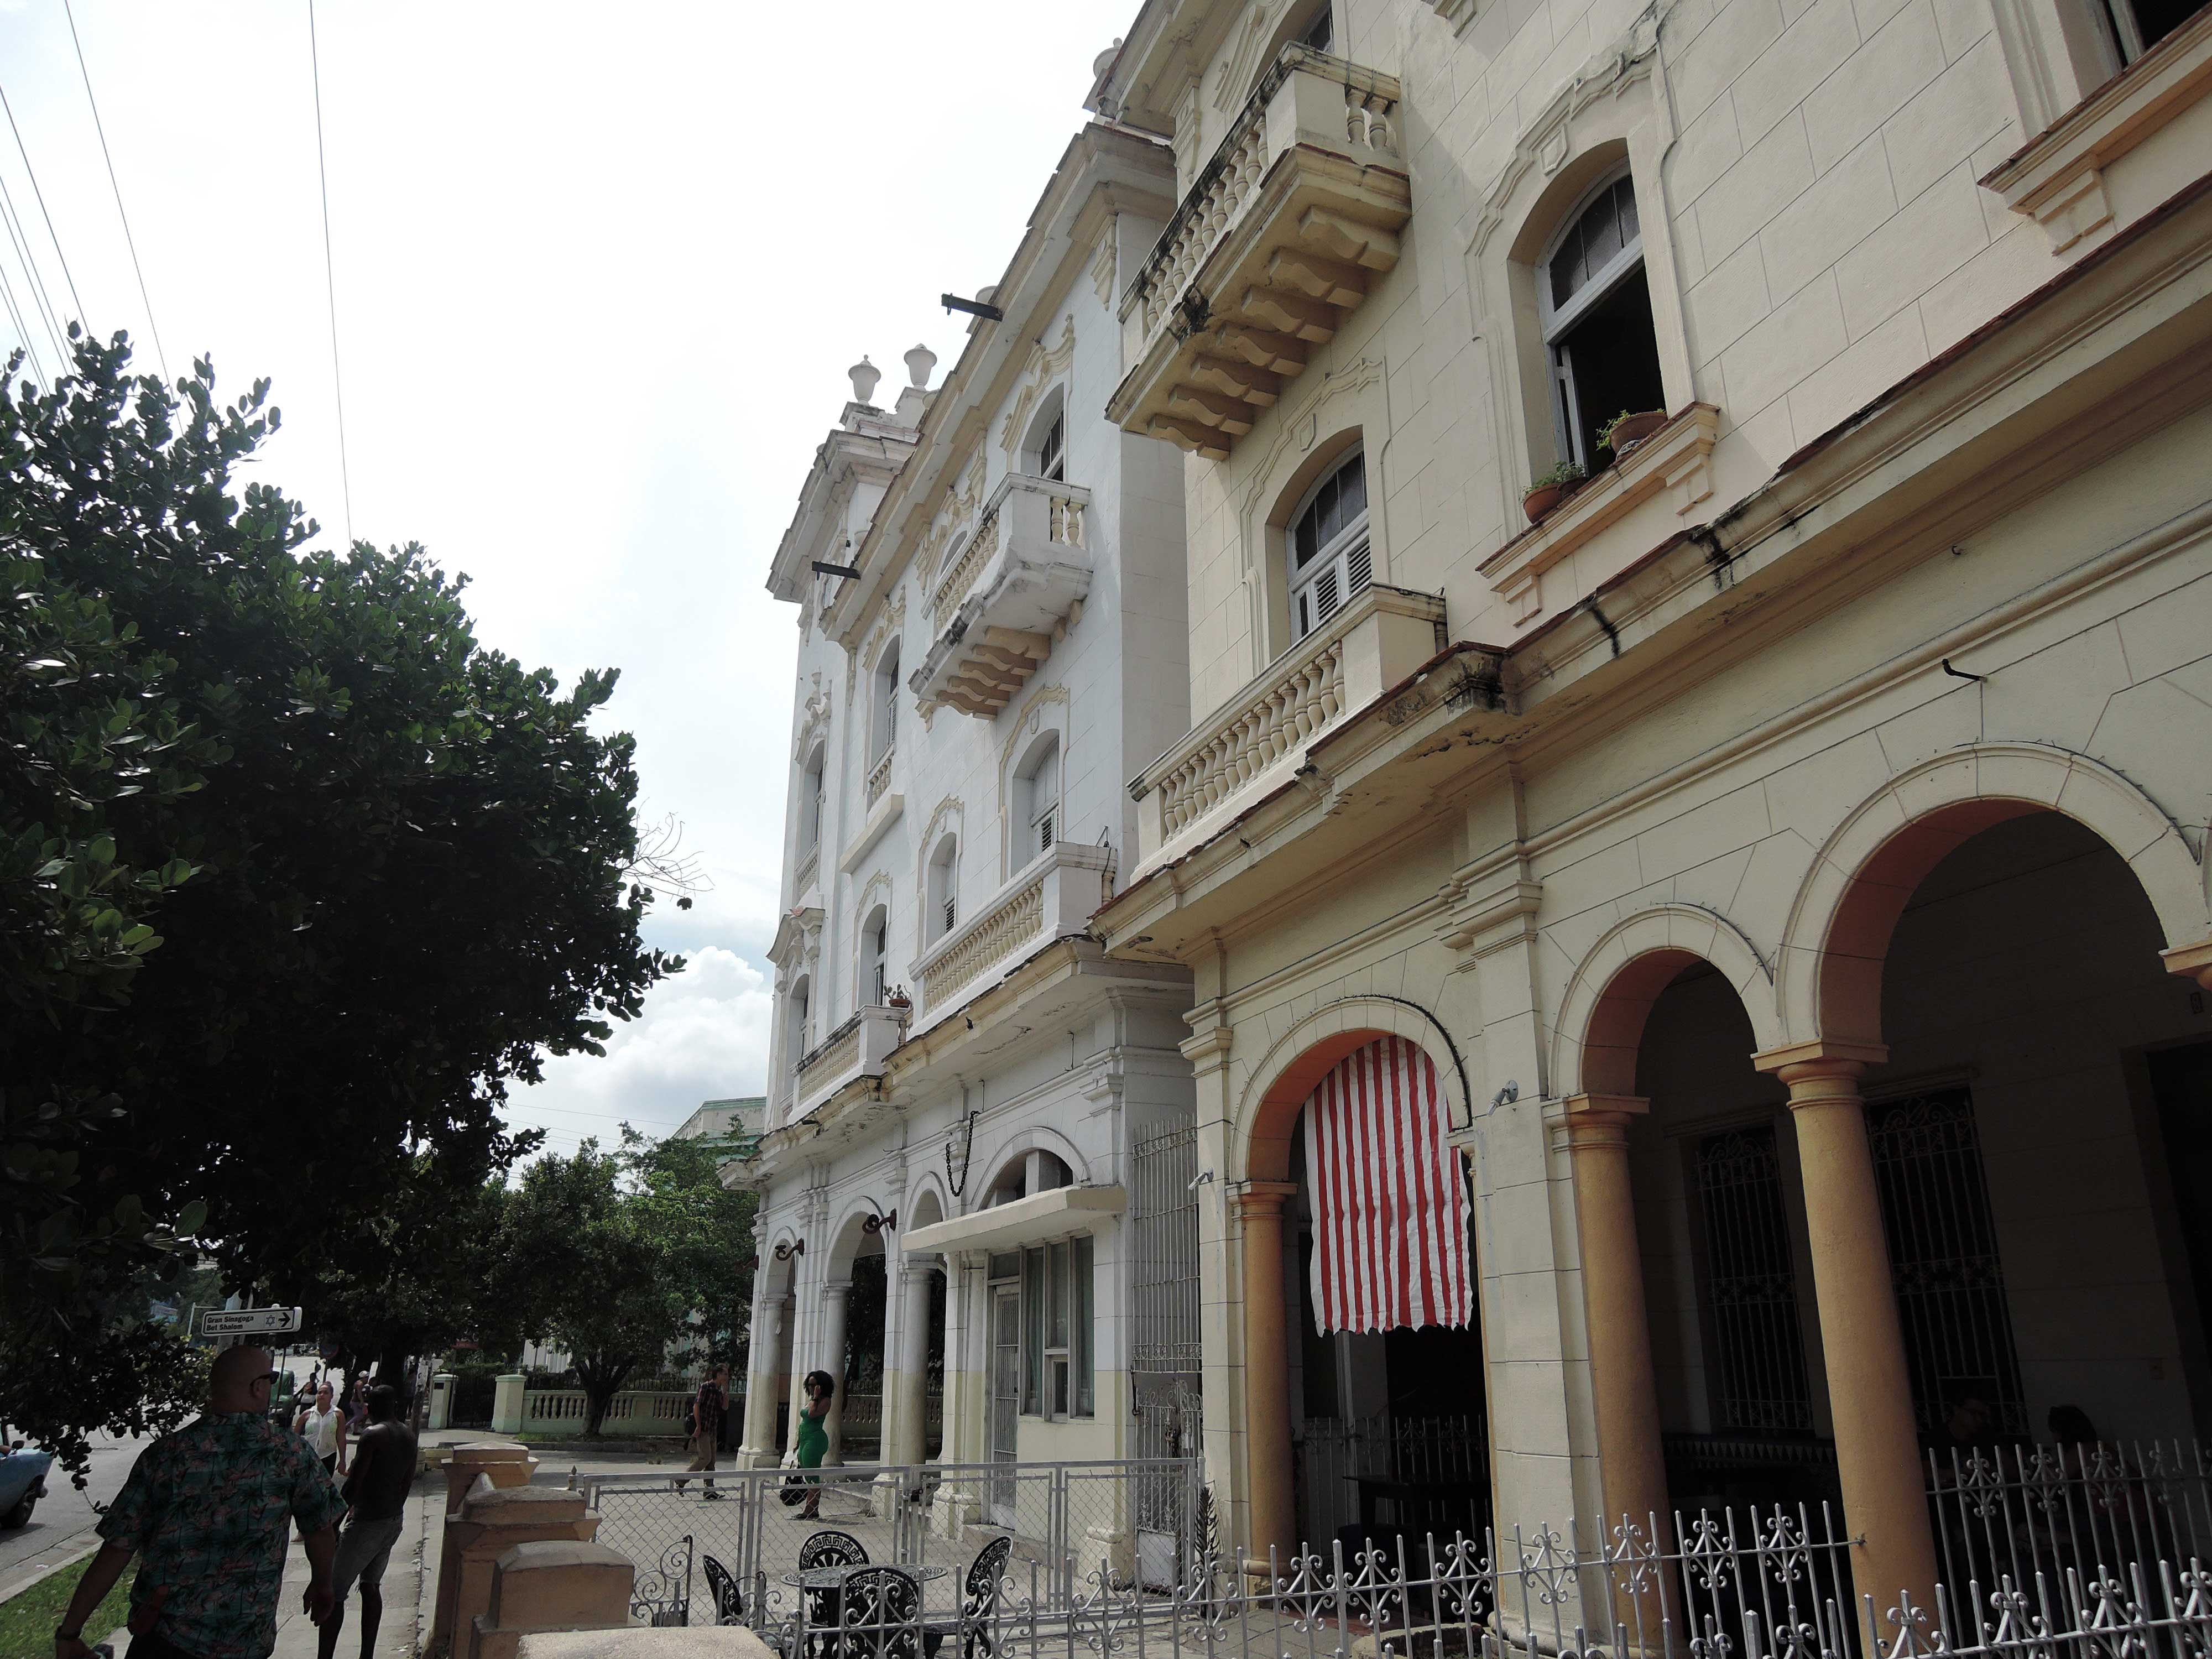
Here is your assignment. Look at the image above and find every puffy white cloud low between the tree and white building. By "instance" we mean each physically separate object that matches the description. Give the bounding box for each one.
[507,945,770,1148]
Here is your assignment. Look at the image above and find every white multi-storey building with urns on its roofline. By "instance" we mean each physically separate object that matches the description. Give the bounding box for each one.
[739,124,1197,1502]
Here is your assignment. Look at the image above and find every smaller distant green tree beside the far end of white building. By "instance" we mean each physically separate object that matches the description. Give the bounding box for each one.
[487,1128,754,1436]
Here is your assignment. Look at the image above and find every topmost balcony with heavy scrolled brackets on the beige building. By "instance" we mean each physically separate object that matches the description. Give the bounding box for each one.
[1106,46,1413,460]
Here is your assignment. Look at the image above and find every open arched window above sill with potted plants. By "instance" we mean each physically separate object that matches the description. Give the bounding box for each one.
[1537,170,1666,471]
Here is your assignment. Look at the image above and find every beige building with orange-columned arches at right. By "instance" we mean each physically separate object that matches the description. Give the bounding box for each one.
[1091,0,2212,1606]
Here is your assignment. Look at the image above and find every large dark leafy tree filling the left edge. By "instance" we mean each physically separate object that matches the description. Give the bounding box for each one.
[0,334,679,1462]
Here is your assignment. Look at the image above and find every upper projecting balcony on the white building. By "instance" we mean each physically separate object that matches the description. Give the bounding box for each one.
[907,473,1091,719]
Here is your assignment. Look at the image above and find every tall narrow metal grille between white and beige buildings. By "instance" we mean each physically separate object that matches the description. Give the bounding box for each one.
[1130,1128,1206,1586]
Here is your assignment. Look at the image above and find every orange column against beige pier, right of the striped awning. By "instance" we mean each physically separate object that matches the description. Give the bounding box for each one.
[1559,1095,1668,1540]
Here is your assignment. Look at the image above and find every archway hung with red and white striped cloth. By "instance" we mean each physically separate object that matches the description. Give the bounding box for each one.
[1239,1026,1491,1555]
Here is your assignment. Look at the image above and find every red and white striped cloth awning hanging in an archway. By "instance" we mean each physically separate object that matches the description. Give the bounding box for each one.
[1305,1037,1475,1334]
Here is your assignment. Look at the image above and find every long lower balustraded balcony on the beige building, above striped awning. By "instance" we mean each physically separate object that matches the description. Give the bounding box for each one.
[1128,586,1444,876]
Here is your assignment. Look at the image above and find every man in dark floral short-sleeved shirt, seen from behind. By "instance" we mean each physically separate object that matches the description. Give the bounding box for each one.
[53,1347,345,1659]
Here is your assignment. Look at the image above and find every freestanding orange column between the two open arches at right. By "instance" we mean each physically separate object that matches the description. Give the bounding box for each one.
[1752,1037,1936,1641]
